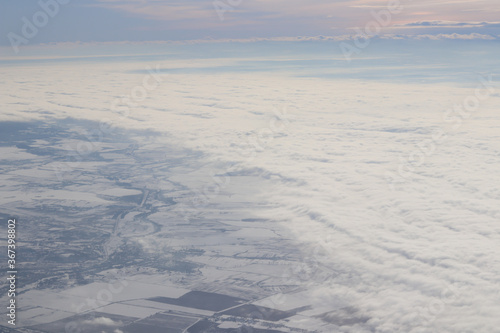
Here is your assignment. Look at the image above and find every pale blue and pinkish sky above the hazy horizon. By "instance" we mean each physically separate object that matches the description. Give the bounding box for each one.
[0,0,500,46]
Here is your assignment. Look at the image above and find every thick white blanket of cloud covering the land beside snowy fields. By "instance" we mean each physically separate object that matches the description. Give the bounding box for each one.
[0,42,500,333]
